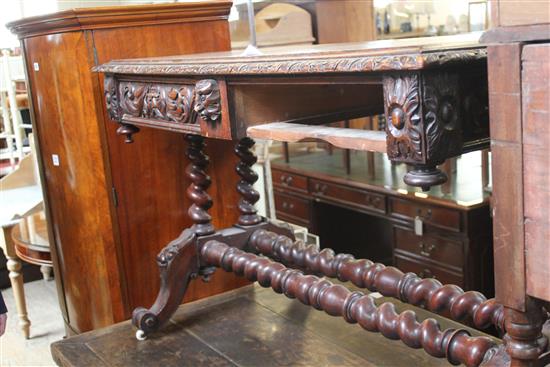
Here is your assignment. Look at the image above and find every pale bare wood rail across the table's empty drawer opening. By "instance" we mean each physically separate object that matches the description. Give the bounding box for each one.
[247,122,386,153]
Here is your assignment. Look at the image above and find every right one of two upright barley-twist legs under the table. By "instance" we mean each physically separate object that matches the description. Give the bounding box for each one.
[235,137,262,226]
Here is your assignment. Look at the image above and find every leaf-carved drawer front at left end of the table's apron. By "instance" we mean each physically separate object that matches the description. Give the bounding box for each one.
[104,74,221,143]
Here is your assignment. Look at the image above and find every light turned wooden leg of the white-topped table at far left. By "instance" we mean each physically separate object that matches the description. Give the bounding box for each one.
[0,226,31,339]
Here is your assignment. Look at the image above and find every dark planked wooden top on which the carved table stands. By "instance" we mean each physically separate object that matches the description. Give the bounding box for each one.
[52,285,500,367]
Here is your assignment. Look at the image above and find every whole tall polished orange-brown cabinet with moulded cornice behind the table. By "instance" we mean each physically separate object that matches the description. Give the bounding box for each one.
[12,2,248,332]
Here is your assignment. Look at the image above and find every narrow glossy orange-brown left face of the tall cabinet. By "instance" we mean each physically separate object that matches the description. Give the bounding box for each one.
[24,33,127,331]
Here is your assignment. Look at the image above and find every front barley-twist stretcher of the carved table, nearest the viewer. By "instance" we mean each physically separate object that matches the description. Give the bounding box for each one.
[200,241,496,366]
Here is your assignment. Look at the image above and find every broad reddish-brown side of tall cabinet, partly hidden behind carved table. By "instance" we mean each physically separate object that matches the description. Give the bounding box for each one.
[94,21,246,316]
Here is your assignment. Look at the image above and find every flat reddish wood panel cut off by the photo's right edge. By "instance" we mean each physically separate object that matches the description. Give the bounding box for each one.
[522,44,550,301]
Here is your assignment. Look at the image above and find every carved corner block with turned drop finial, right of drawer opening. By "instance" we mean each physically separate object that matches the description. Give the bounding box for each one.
[383,70,488,190]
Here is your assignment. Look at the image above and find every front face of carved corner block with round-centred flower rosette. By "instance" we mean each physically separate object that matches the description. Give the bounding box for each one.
[383,74,425,163]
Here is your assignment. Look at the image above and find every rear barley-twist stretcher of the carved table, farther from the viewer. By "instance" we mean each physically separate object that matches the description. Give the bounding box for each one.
[249,229,504,329]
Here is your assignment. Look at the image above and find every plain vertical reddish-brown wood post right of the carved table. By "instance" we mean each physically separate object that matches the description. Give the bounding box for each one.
[488,44,525,310]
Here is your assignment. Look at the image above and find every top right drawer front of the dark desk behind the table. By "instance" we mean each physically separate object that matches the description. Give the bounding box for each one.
[390,198,461,232]
